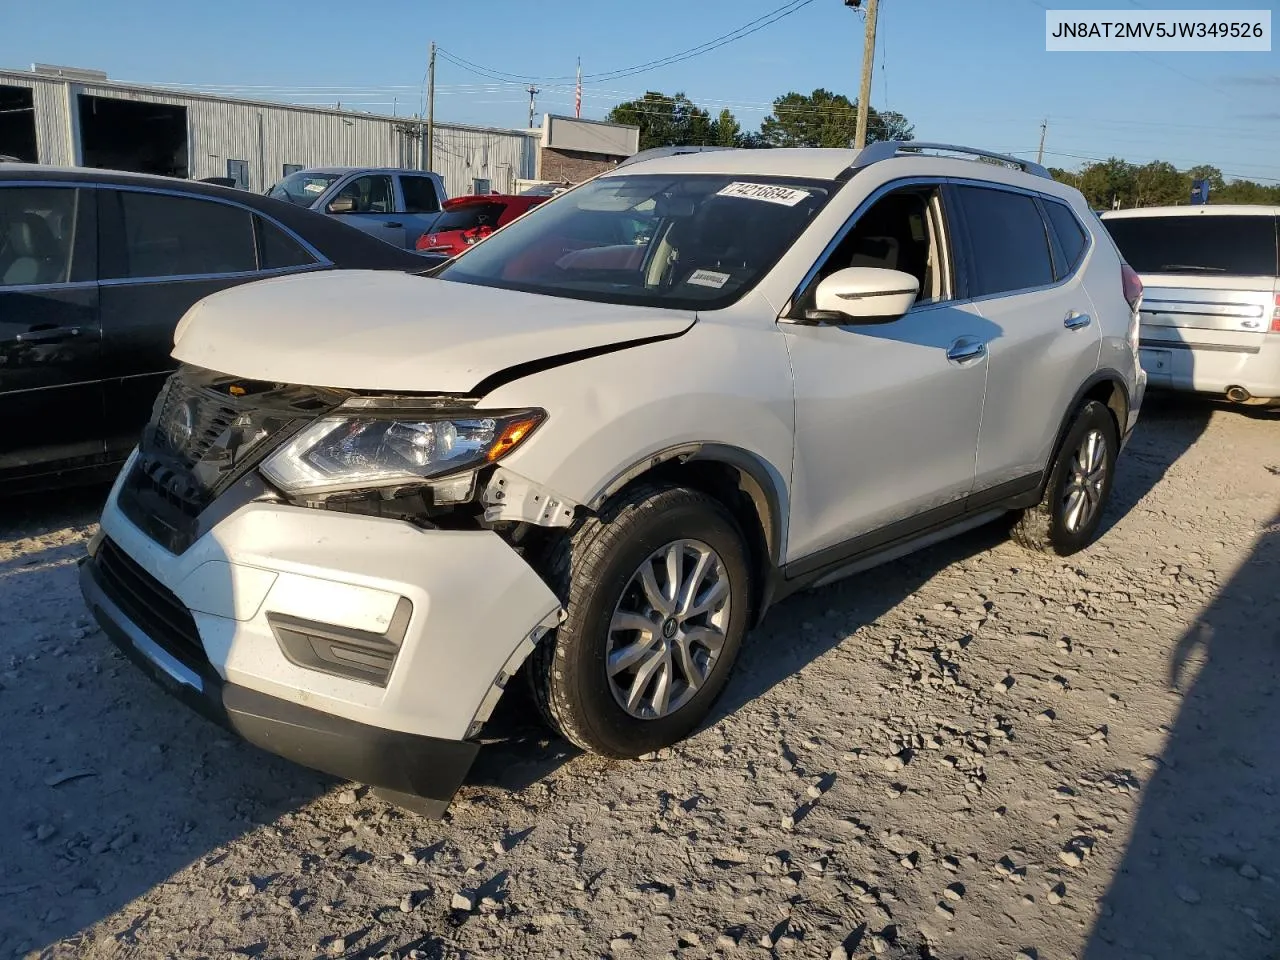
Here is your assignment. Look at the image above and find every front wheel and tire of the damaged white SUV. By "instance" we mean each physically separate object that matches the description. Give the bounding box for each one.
[529,485,751,759]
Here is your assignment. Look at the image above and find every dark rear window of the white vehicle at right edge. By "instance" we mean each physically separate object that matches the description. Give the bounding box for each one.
[1102,214,1277,276]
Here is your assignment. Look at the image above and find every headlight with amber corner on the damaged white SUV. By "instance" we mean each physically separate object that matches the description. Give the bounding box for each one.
[262,410,547,494]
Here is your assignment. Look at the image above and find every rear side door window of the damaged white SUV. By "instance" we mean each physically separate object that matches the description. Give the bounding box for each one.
[956,187,1053,297]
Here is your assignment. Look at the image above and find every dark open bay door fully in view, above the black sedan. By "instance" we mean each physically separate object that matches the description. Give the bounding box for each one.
[79,93,188,179]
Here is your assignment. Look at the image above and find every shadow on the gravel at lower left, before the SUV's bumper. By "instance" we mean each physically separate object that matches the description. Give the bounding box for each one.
[0,489,337,956]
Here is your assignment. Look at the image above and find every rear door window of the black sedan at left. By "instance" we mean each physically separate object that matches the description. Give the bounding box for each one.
[113,191,257,279]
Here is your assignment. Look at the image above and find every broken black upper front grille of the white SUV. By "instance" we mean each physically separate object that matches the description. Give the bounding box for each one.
[119,366,347,553]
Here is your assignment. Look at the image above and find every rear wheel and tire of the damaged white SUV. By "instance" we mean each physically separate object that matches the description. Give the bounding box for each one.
[1012,401,1120,557]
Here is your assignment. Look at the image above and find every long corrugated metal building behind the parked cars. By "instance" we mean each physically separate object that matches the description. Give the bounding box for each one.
[0,70,540,196]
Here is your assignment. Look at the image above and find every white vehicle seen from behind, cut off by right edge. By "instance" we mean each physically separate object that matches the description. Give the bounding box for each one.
[1102,204,1280,406]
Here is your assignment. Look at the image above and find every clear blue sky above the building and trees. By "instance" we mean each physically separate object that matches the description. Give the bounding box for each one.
[0,0,1280,183]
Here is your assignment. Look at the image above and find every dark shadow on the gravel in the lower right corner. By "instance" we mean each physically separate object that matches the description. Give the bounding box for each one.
[1083,513,1280,960]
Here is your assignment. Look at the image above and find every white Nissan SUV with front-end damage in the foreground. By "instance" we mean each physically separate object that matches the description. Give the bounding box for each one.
[82,143,1144,813]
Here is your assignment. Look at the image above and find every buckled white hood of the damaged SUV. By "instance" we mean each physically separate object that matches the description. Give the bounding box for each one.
[173,270,694,393]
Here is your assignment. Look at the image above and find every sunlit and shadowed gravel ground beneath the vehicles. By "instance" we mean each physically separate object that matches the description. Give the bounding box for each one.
[0,402,1280,960]
